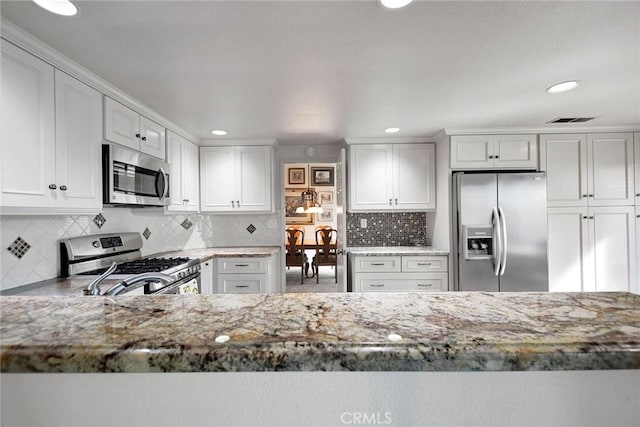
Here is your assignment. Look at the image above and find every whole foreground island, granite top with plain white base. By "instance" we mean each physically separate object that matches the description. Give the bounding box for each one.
[0,292,640,427]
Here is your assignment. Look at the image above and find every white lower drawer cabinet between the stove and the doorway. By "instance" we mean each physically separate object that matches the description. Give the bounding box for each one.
[214,257,269,294]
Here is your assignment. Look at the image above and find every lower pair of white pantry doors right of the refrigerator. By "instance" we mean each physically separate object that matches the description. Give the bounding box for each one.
[548,206,638,292]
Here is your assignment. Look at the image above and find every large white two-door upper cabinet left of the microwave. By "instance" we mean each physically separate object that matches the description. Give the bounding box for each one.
[0,41,102,213]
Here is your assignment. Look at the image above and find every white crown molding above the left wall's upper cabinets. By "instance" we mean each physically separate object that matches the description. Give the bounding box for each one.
[0,18,199,142]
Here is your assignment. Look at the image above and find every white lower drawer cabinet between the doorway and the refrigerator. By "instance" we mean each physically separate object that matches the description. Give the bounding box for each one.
[351,255,449,292]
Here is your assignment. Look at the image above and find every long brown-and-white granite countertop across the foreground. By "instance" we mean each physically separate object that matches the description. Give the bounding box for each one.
[0,292,640,372]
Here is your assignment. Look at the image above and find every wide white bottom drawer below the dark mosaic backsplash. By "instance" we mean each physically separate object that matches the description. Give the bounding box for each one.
[358,273,448,292]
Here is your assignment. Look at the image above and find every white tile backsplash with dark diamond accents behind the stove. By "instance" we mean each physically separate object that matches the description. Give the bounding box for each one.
[0,208,283,289]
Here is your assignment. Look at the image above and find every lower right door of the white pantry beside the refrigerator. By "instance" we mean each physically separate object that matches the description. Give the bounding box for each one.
[585,206,637,292]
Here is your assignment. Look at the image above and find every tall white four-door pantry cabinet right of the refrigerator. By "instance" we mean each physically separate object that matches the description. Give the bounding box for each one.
[540,133,640,292]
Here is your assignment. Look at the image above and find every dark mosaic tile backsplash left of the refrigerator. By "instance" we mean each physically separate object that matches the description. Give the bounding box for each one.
[347,212,433,246]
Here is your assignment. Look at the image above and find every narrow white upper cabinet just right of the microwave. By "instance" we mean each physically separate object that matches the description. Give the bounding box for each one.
[167,131,200,212]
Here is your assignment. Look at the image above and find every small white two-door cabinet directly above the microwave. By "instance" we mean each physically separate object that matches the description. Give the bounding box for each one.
[104,96,166,159]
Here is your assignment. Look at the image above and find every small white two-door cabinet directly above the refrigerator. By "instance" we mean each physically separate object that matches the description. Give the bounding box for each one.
[450,135,538,170]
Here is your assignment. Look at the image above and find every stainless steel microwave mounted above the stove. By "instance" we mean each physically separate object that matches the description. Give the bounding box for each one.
[102,144,170,206]
